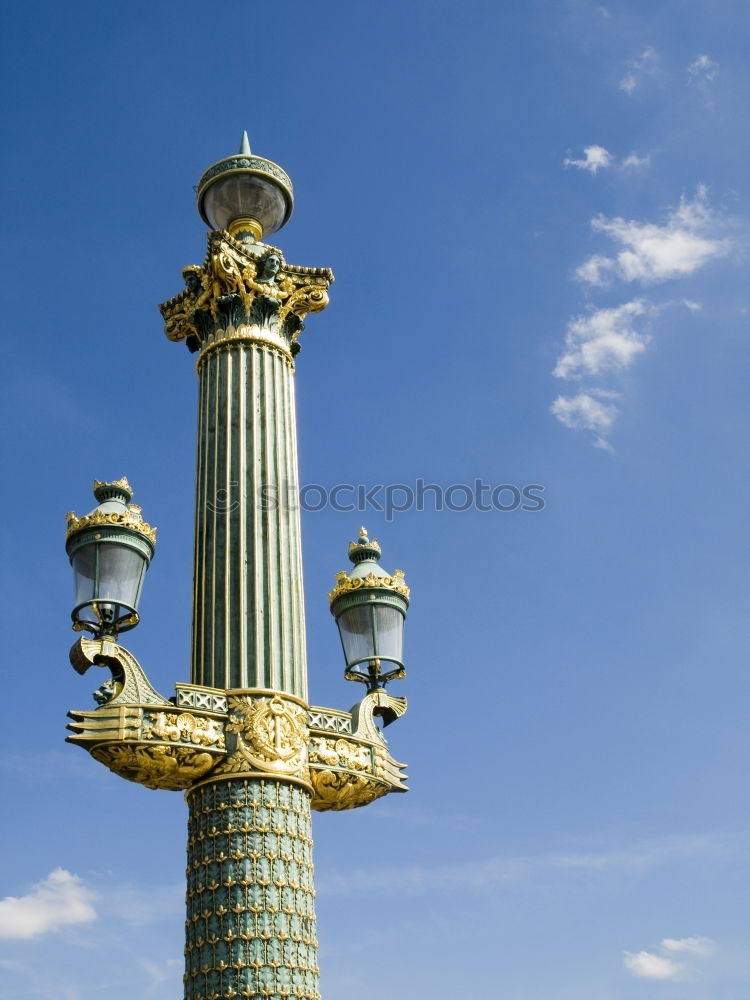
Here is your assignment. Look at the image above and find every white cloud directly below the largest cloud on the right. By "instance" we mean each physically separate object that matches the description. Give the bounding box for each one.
[553,299,654,380]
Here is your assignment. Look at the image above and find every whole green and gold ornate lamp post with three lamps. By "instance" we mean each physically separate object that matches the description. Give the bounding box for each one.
[66,134,409,1000]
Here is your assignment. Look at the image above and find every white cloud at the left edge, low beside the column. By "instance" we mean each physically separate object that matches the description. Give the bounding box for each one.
[0,868,97,939]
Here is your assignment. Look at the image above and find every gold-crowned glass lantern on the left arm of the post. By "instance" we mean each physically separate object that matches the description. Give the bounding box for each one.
[65,478,156,638]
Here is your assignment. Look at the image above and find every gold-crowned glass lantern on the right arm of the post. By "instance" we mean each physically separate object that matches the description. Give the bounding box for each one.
[328,528,409,691]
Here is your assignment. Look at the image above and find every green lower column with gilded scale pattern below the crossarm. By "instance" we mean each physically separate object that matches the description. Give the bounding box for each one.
[185,778,320,1000]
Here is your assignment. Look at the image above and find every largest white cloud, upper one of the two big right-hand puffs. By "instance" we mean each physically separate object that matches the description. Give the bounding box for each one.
[575,185,733,286]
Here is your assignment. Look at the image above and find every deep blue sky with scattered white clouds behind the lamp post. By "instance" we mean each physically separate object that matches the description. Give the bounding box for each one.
[0,0,750,1000]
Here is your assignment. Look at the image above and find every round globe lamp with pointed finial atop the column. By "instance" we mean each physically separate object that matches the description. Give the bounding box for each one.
[196,132,294,242]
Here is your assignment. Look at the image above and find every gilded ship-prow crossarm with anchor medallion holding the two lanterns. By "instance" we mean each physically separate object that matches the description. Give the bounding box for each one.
[68,638,407,811]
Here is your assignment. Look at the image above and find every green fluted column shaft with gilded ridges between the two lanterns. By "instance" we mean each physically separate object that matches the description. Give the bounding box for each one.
[191,340,307,700]
